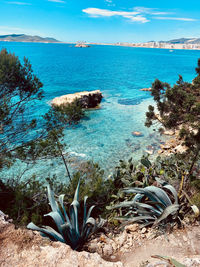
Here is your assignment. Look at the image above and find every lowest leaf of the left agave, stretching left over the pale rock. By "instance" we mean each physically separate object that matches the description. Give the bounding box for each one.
[27,222,65,243]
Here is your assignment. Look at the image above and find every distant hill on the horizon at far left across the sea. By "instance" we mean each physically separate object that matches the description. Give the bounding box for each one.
[0,34,60,43]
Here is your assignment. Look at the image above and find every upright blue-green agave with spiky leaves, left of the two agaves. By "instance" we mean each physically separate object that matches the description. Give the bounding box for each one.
[27,180,105,250]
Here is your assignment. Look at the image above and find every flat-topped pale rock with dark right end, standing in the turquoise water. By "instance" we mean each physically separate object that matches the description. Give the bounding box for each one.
[51,90,103,108]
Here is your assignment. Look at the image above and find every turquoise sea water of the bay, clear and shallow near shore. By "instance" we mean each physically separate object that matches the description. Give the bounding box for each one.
[0,42,200,180]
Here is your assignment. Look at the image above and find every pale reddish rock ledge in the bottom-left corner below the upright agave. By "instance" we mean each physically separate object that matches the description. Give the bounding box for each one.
[0,214,123,267]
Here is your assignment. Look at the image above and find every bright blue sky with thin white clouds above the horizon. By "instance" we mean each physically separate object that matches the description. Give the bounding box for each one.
[0,0,200,42]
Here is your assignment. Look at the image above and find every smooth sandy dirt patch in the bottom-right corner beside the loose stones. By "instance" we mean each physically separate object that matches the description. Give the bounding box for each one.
[120,226,200,267]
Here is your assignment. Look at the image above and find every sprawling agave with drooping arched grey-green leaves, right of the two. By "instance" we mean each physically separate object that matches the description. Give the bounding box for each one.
[107,179,180,226]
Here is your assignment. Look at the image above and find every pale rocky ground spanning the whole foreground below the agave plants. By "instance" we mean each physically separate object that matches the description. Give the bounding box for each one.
[0,212,200,267]
